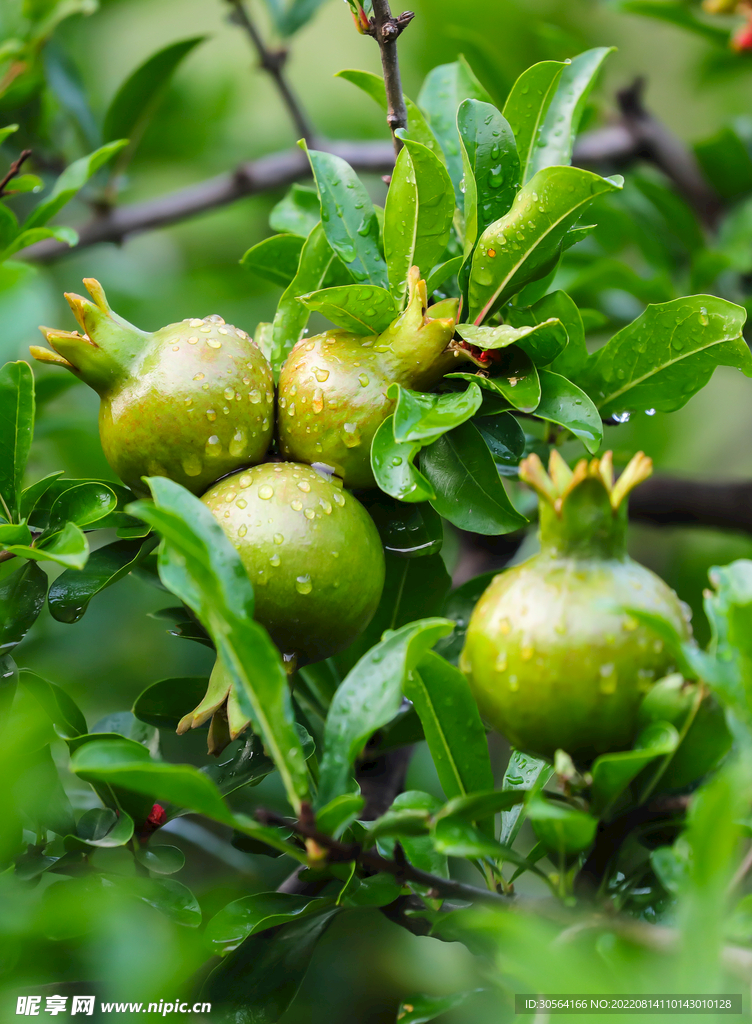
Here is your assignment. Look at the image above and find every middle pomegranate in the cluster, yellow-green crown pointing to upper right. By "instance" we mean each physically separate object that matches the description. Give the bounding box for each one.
[278,267,463,487]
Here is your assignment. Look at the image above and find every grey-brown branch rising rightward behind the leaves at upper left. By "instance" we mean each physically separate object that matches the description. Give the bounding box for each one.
[18,141,394,263]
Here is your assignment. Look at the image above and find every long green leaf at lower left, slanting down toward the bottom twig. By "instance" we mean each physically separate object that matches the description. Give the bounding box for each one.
[71,739,234,824]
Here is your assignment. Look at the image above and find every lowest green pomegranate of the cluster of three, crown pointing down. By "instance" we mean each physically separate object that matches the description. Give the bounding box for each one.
[178,463,384,753]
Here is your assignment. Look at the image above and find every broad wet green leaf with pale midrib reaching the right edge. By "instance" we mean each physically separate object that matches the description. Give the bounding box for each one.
[580,295,752,417]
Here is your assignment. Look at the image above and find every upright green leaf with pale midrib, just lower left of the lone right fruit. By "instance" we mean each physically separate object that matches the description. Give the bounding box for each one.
[405,652,494,799]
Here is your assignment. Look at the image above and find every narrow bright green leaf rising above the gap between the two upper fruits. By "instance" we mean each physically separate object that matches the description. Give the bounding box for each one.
[267,222,346,378]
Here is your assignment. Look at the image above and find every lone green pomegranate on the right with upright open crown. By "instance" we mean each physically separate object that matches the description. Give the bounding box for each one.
[460,451,690,763]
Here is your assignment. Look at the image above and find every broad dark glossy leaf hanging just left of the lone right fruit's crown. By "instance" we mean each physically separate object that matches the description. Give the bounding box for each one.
[420,423,528,535]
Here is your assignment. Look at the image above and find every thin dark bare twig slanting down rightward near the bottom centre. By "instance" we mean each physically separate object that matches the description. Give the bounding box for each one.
[255,808,510,906]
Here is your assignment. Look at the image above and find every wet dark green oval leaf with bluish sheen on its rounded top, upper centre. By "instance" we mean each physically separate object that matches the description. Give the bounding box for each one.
[457,99,519,260]
